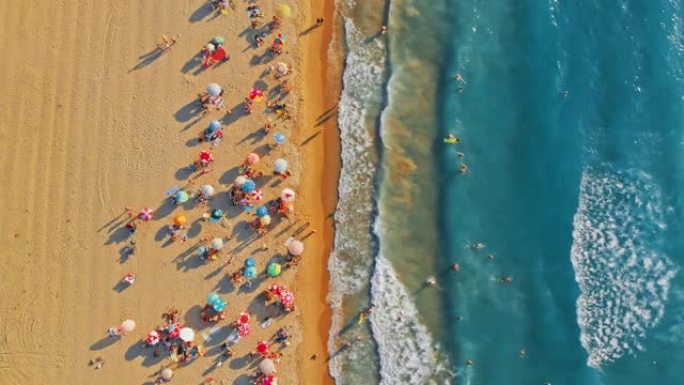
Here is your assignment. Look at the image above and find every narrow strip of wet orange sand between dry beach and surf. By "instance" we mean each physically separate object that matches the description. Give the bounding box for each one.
[295,0,342,385]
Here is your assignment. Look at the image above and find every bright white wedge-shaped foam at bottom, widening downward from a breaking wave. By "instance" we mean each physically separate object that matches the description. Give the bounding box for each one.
[370,255,451,385]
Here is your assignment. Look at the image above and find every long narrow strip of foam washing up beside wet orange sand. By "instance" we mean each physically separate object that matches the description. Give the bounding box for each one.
[328,20,385,384]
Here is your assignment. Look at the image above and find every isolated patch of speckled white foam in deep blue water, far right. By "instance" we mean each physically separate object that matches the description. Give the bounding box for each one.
[571,169,676,367]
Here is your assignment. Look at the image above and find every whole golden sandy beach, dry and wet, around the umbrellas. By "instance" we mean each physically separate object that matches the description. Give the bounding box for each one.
[0,0,339,385]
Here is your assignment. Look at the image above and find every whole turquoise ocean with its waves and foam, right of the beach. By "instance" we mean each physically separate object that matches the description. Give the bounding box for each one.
[328,0,684,385]
